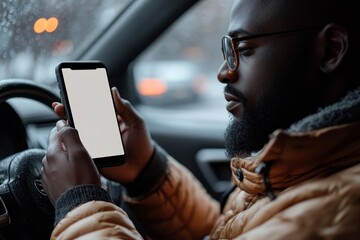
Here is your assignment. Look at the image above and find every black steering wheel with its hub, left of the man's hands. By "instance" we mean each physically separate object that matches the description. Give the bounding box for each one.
[0,79,60,239]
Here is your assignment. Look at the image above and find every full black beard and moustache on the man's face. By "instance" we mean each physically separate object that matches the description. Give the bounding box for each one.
[225,85,309,158]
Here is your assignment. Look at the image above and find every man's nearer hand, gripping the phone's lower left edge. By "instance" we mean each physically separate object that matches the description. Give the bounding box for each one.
[41,120,101,204]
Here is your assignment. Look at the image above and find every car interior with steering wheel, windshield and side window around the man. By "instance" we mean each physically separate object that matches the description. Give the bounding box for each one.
[0,0,233,239]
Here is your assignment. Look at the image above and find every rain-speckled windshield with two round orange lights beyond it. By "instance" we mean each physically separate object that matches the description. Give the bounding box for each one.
[0,0,132,85]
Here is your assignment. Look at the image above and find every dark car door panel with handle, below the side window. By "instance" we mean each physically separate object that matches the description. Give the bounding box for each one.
[139,108,231,199]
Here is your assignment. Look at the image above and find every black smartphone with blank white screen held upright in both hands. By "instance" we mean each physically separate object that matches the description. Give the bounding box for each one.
[55,61,125,168]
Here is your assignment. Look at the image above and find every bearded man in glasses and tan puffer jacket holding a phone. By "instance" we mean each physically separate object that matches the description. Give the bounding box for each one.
[42,0,360,239]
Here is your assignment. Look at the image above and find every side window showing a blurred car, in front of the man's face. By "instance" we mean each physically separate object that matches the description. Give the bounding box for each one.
[132,0,233,121]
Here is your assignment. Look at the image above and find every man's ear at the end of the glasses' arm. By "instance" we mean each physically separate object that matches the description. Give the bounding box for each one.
[318,23,349,73]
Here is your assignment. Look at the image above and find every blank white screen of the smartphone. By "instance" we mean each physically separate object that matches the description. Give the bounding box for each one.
[62,68,124,158]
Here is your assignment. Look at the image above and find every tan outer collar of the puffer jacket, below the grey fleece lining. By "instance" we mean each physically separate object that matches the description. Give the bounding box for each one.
[231,123,360,194]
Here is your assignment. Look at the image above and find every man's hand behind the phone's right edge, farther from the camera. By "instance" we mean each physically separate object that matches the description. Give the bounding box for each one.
[49,88,154,183]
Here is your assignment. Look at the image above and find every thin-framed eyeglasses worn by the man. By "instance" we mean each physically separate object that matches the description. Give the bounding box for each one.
[221,28,319,71]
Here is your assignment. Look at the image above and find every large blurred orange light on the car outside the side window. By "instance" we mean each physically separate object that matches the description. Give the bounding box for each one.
[138,78,167,96]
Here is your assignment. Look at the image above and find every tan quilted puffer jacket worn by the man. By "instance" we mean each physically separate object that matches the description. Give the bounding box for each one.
[52,123,360,240]
